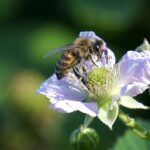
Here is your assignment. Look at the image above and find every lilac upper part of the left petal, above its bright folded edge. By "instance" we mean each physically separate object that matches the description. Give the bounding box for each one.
[37,75,86,101]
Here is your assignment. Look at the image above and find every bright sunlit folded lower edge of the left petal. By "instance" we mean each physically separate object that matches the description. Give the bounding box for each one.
[50,100,98,117]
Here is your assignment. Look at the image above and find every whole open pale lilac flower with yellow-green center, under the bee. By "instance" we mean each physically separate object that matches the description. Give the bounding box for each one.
[37,32,150,128]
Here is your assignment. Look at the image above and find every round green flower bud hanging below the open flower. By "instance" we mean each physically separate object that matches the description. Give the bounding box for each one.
[70,126,99,150]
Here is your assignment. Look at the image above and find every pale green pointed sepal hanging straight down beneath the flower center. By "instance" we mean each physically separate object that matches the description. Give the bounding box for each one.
[98,103,119,129]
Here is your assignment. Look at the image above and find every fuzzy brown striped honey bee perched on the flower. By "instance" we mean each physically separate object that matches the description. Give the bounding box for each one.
[45,32,106,80]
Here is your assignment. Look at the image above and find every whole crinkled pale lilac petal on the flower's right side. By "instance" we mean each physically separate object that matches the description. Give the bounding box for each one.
[111,51,150,108]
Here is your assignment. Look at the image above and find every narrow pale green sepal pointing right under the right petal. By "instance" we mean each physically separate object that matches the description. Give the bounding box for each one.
[119,96,149,109]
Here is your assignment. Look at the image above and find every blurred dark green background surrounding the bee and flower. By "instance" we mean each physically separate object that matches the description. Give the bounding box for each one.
[0,0,150,150]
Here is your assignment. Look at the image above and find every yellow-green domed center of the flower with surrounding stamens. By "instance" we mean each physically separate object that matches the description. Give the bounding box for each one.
[87,68,114,100]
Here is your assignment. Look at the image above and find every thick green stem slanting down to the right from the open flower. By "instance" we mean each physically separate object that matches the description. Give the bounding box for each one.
[119,110,150,141]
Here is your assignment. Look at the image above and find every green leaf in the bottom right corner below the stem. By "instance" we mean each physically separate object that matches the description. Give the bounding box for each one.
[112,120,150,150]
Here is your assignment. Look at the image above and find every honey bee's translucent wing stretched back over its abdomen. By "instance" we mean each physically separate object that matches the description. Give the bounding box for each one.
[44,45,78,58]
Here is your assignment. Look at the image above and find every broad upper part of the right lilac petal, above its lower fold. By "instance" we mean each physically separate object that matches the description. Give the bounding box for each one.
[120,51,150,85]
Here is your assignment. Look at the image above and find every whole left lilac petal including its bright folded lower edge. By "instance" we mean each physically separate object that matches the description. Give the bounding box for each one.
[37,75,98,117]
